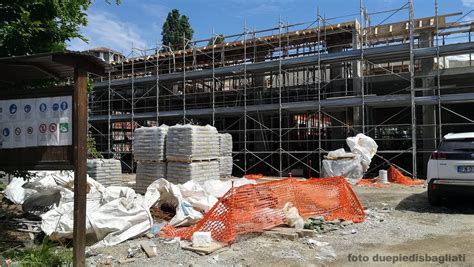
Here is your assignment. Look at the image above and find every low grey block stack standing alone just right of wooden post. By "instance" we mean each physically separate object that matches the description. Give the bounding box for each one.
[87,159,122,187]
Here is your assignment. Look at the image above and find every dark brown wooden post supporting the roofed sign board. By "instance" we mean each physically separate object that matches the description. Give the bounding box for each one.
[72,64,87,266]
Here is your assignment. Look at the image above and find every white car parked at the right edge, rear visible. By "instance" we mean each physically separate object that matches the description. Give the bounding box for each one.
[426,132,474,206]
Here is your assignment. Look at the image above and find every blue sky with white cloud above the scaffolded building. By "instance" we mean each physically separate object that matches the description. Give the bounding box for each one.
[69,0,474,55]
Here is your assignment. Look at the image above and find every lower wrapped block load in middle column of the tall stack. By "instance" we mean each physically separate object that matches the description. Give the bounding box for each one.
[166,160,219,184]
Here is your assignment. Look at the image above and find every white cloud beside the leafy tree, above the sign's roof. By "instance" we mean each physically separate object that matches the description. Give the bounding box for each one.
[68,11,146,55]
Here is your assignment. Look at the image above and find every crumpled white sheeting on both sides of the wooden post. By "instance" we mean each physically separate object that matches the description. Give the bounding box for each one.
[41,186,153,247]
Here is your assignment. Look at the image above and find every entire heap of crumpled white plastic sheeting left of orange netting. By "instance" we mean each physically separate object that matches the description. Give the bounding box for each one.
[41,176,217,247]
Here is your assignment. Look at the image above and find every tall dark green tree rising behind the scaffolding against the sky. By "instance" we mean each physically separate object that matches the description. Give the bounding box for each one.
[161,9,194,51]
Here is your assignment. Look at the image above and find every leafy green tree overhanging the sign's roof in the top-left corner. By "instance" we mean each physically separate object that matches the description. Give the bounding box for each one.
[0,0,120,57]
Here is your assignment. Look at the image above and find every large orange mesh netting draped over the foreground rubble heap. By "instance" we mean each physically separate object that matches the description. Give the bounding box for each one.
[160,177,365,243]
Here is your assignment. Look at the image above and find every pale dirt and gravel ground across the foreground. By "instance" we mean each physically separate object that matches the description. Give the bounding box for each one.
[87,185,474,266]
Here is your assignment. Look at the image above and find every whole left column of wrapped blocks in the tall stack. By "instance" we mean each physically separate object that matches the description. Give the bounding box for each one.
[133,125,168,194]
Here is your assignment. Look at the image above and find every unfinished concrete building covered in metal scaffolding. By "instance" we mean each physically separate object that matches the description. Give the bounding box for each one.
[89,1,474,178]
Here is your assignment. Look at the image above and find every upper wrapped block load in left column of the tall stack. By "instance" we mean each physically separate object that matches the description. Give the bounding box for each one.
[133,125,168,162]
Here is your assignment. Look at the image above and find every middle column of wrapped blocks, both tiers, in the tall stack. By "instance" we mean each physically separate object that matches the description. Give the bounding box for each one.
[166,124,219,184]
